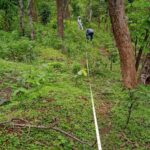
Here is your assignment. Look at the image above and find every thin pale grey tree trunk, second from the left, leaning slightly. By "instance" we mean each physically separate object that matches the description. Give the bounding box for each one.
[28,0,35,40]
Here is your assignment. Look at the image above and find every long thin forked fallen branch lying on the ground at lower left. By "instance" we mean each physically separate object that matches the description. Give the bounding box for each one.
[0,121,91,146]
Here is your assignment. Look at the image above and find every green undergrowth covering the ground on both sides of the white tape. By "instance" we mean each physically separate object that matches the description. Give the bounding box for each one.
[0,21,150,150]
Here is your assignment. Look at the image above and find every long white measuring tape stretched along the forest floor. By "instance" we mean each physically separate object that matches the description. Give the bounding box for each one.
[86,52,102,150]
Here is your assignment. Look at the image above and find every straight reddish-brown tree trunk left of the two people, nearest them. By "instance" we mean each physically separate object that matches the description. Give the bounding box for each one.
[56,0,64,39]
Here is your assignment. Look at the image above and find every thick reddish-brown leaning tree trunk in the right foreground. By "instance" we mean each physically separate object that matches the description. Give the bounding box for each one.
[109,0,137,89]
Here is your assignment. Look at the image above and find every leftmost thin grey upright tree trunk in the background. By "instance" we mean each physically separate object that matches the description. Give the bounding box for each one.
[19,0,24,36]
